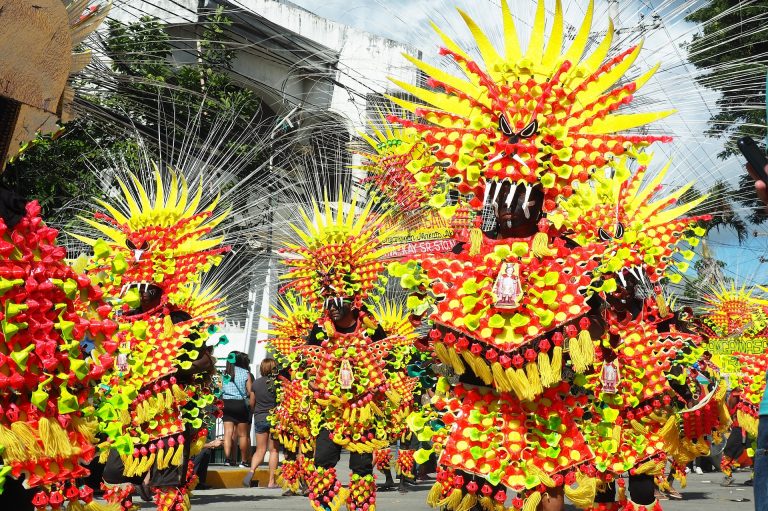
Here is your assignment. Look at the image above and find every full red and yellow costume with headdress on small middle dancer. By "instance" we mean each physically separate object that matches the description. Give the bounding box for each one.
[281,200,413,510]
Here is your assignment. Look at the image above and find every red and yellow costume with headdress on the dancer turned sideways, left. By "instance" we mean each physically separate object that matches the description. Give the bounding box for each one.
[76,170,227,511]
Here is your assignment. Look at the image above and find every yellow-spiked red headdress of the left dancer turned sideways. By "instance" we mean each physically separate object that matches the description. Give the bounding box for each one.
[73,169,228,300]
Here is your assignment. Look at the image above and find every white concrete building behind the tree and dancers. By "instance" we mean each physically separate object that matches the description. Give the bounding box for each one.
[106,0,422,369]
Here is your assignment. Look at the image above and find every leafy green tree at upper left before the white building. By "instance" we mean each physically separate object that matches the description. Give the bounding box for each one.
[0,9,268,226]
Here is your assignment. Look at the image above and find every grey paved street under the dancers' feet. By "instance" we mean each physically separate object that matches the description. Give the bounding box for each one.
[134,459,754,511]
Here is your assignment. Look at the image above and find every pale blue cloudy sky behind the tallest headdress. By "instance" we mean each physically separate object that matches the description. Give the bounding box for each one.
[292,0,768,283]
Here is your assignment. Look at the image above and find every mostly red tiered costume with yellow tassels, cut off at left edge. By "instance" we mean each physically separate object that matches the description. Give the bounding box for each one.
[0,202,117,509]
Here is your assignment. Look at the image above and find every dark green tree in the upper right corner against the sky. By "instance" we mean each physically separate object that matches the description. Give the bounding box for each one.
[686,0,768,224]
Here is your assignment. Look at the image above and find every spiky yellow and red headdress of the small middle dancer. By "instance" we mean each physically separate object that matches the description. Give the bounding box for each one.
[280,193,393,308]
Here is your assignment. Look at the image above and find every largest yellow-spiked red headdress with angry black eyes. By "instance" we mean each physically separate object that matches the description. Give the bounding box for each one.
[390,0,672,213]
